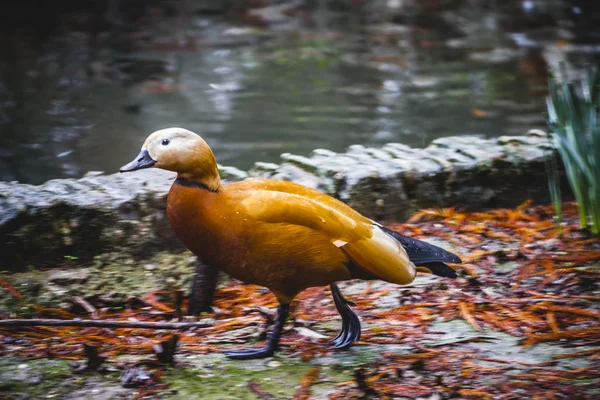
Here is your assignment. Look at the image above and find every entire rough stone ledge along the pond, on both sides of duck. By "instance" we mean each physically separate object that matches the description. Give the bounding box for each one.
[0,131,564,271]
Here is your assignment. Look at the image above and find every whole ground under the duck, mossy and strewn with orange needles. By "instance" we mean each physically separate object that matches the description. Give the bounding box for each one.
[0,204,600,400]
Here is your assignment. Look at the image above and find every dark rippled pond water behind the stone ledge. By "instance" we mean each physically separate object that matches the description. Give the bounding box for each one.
[0,0,600,184]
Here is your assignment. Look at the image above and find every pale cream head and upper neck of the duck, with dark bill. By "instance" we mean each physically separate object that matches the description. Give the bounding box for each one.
[119,128,220,190]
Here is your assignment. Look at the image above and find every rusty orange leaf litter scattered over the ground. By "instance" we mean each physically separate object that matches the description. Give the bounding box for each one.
[0,204,600,399]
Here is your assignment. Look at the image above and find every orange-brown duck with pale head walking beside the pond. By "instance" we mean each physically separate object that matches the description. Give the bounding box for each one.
[120,127,461,359]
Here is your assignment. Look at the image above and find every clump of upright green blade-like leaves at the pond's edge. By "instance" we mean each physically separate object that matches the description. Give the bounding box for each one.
[546,62,600,235]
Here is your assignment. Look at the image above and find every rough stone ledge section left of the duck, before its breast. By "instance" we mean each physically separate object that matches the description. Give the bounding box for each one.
[0,170,182,270]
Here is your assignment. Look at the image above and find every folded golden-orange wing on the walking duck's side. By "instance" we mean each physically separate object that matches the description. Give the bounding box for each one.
[240,190,416,284]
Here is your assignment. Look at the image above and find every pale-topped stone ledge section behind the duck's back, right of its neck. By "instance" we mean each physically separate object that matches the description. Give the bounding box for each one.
[249,130,552,220]
